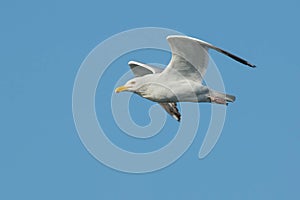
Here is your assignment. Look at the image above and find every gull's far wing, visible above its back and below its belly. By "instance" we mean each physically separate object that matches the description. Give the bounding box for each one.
[128,61,181,121]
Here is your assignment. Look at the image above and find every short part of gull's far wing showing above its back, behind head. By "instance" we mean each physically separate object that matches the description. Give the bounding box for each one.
[128,61,163,77]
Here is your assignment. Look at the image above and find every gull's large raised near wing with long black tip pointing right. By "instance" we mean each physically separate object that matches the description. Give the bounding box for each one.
[162,35,255,82]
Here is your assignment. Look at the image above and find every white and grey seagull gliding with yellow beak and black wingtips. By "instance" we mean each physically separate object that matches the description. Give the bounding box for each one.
[115,35,255,121]
